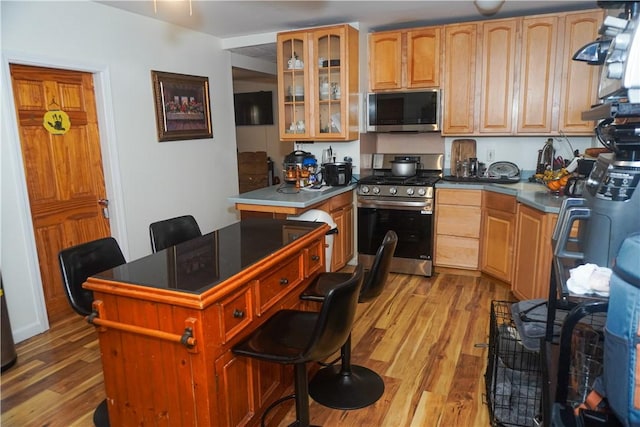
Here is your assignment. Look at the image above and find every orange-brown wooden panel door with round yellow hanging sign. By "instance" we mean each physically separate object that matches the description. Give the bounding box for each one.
[11,64,111,323]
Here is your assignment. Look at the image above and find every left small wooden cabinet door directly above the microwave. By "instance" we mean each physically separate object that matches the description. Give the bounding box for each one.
[369,31,402,91]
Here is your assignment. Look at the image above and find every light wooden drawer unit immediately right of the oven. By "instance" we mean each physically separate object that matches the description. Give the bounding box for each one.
[434,188,482,270]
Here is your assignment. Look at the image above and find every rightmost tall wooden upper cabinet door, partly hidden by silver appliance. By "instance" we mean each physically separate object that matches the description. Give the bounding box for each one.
[558,11,603,135]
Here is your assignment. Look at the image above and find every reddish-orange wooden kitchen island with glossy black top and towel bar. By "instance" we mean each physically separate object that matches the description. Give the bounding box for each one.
[84,219,329,426]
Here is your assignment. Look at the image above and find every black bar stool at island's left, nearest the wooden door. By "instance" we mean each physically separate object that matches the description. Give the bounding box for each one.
[58,237,126,427]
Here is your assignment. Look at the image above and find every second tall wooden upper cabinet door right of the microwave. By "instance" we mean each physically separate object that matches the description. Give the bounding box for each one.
[478,19,521,134]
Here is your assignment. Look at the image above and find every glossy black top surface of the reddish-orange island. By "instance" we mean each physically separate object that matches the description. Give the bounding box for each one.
[94,219,325,294]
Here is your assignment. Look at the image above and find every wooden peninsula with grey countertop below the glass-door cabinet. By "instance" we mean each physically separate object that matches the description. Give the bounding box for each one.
[228,183,356,271]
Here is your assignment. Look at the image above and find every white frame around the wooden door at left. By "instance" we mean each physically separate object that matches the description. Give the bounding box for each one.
[2,51,129,341]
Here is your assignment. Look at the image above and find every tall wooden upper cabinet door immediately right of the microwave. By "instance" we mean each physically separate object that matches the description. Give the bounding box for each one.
[442,24,477,135]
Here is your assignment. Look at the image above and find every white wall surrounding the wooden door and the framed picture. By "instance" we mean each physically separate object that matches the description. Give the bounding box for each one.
[0,0,238,341]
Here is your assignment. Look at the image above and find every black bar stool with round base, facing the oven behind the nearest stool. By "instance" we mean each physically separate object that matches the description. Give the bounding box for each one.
[300,230,398,409]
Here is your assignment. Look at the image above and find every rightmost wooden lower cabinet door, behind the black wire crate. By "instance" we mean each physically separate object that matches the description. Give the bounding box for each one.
[511,204,558,300]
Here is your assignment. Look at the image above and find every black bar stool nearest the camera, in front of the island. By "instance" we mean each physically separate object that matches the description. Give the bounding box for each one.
[233,265,364,427]
